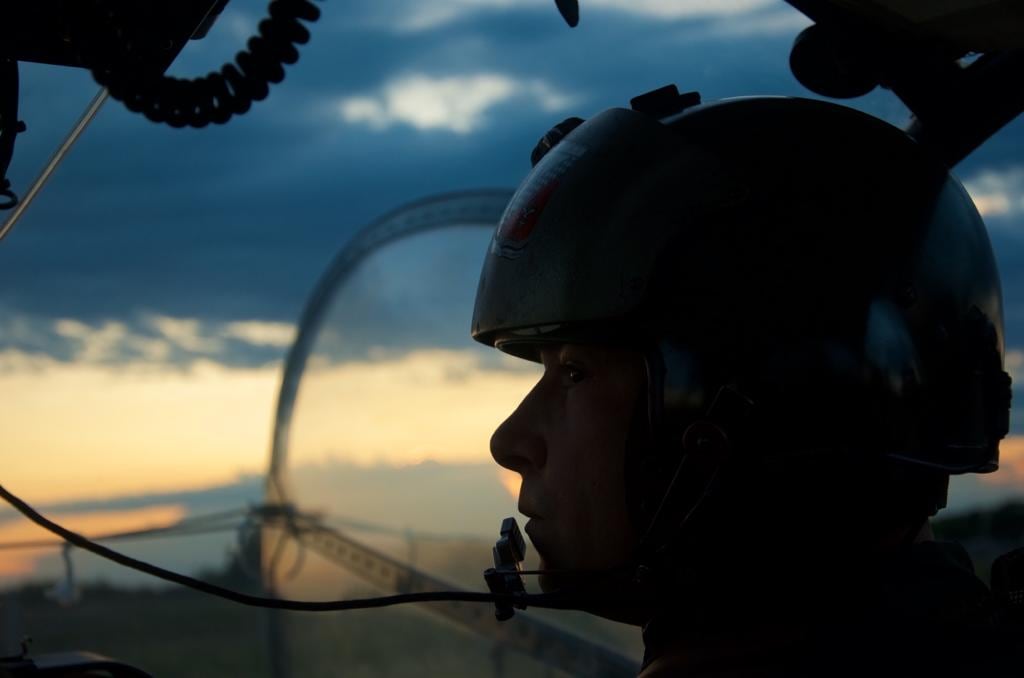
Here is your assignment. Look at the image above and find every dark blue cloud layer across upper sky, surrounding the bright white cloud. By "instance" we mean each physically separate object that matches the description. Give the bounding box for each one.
[0,2,1024,383]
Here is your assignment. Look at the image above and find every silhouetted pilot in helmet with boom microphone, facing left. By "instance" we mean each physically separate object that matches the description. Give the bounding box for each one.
[472,87,1024,678]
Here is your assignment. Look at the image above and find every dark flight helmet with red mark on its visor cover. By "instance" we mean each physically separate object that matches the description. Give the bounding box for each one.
[472,87,1010,569]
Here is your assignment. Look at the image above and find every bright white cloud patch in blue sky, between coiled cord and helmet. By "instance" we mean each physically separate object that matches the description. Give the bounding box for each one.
[336,73,572,134]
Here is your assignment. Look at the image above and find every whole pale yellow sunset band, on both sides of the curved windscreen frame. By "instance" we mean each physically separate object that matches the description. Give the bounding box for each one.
[0,350,536,502]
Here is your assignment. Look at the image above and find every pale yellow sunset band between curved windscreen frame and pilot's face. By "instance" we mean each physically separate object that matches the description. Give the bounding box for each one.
[288,347,540,464]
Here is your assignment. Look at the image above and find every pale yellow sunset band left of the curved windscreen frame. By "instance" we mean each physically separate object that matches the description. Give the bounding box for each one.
[0,349,280,501]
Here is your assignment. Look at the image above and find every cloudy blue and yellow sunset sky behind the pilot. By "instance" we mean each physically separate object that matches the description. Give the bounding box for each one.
[0,0,1024,585]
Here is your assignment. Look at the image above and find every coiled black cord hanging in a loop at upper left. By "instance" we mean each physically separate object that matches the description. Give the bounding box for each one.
[66,0,321,127]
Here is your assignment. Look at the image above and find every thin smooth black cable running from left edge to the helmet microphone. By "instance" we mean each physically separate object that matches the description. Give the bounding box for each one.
[0,485,636,612]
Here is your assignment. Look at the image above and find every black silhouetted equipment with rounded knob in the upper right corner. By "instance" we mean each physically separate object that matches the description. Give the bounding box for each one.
[786,0,1024,167]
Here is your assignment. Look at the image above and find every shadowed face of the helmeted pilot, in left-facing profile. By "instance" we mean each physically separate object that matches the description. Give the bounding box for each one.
[490,344,645,590]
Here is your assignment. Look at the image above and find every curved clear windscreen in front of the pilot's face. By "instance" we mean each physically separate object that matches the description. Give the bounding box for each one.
[262,196,640,676]
